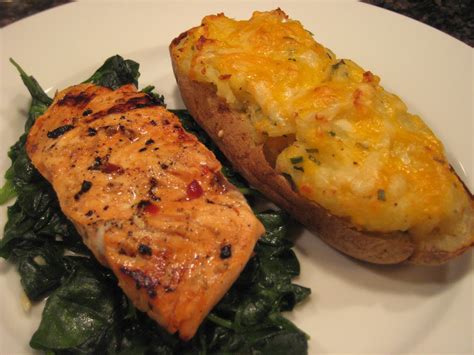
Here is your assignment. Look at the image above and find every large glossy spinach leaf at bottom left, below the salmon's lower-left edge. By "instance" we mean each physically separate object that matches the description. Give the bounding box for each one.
[30,259,120,353]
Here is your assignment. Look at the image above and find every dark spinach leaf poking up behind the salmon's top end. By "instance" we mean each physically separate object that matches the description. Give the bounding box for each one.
[85,55,140,90]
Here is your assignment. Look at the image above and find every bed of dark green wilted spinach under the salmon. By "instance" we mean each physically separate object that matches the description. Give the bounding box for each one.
[0,56,310,354]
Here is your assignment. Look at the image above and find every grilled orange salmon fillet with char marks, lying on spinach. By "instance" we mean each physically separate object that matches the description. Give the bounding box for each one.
[26,84,264,340]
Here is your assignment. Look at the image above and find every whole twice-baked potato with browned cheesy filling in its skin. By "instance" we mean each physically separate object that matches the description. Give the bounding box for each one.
[170,9,474,264]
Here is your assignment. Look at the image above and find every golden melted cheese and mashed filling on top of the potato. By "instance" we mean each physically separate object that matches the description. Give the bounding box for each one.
[175,10,469,236]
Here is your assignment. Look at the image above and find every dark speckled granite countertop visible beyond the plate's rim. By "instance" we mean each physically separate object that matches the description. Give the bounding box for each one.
[0,0,474,47]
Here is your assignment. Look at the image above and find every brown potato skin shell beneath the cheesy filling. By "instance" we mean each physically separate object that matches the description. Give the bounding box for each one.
[170,40,474,265]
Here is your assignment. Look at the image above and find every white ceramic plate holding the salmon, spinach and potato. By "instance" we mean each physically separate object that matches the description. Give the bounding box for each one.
[0,0,474,354]
